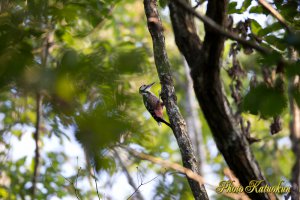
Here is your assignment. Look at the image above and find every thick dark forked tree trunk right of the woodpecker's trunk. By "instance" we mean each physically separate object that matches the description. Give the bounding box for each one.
[169,0,276,199]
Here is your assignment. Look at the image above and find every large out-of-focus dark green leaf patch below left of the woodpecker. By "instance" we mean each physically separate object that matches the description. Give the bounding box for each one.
[75,104,132,169]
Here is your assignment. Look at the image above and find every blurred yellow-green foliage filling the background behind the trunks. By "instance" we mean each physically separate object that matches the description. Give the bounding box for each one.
[0,0,300,199]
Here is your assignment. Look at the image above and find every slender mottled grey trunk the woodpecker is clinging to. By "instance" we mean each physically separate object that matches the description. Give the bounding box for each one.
[144,0,208,199]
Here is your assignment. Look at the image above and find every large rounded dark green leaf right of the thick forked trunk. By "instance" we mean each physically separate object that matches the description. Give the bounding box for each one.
[242,83,287,118]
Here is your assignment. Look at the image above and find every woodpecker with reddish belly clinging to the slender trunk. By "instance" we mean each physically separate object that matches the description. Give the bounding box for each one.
[139,82,171,128]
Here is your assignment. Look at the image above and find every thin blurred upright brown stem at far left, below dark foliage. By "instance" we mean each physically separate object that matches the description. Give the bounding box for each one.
[32,93,42,199]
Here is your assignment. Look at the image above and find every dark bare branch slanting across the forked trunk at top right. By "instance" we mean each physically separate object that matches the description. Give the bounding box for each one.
[174,0,271,54]
